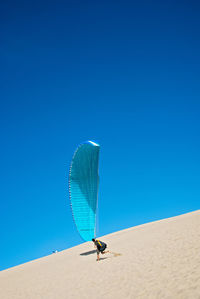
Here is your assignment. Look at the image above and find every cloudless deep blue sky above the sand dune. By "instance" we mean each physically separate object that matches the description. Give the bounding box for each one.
[0,0,200,270]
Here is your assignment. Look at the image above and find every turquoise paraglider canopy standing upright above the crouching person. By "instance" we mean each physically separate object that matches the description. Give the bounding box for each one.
[69,141,100,241]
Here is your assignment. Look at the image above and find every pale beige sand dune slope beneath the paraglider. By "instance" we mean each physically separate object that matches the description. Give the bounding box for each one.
[0,211,200,299]
